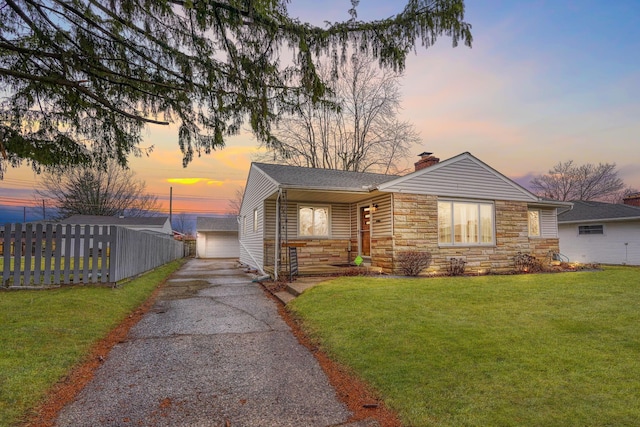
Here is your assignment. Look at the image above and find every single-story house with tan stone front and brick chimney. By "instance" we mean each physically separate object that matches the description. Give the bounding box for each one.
[240,153,571,274]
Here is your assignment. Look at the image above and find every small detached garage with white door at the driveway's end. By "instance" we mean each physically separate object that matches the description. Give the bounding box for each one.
[196,216,240,258]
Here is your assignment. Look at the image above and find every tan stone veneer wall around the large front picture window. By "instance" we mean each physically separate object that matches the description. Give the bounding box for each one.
[384,193,559,274]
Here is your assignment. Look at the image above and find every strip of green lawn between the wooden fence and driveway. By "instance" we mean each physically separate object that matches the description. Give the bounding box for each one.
[0,260,182,426]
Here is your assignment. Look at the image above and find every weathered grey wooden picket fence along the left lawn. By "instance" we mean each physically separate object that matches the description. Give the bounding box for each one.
[0,223,184,288]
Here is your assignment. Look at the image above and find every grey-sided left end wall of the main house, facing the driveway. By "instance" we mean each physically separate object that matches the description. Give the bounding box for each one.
[238,165,278,270]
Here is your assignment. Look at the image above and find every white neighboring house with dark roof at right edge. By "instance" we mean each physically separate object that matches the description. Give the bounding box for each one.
[558,199,640,265]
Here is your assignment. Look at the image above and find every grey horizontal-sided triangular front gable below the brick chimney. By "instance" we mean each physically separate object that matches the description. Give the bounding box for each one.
[380,157,536,201]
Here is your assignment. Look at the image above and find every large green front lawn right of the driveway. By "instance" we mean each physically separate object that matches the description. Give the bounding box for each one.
[289,267,640,426]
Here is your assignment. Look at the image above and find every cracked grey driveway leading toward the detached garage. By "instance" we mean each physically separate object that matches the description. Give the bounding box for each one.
[56,259,364,427]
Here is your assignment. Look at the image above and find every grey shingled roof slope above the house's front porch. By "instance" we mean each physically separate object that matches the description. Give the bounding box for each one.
[254,163,398,191]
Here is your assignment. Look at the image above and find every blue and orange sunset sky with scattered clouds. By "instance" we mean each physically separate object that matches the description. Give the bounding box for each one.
[0,0,640,221]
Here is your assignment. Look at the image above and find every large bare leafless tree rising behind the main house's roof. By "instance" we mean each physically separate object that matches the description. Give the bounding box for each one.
[262,55,420,174]
